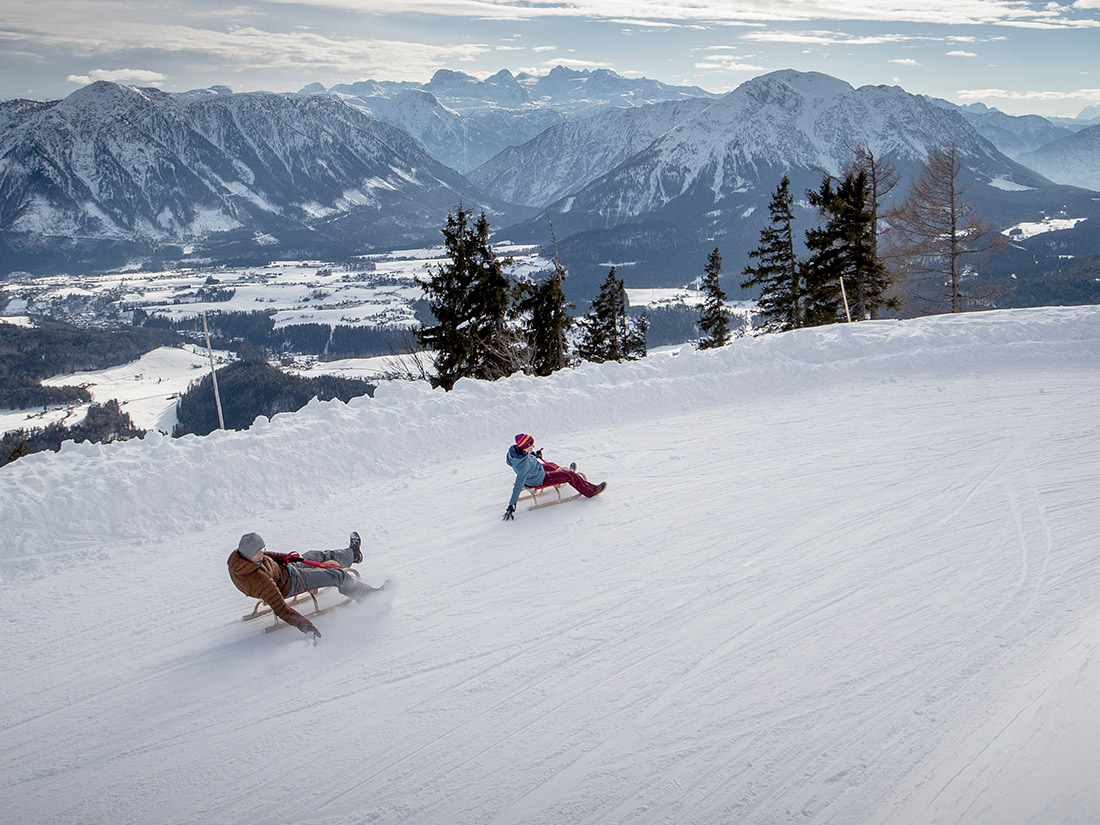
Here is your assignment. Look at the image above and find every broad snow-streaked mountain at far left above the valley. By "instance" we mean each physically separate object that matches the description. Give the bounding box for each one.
[0,83,510,275]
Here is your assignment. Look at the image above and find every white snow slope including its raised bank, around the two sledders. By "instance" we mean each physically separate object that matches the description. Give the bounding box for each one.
[0,307,1100,825]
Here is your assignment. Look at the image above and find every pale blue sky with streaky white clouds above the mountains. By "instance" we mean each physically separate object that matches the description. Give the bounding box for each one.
[0,0,1100,117]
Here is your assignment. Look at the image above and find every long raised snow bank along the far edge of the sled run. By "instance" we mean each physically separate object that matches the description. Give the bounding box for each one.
[0,307,1100,559]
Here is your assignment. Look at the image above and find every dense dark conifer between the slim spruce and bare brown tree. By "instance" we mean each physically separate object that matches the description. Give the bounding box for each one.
[804,172,890,326]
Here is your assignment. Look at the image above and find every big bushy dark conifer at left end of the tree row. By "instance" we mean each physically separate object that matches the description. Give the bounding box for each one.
[417,205,517,389]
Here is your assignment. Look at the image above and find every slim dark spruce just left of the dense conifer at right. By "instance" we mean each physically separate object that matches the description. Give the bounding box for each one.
[741,177,805,332]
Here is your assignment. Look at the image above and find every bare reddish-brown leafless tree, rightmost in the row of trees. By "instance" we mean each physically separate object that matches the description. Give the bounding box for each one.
[884,143,1005,312]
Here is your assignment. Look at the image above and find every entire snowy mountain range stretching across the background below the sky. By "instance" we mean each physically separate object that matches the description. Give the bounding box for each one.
[0,68,1100,301]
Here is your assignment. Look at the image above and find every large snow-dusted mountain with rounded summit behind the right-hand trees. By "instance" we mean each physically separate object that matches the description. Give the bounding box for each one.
[501,70,1100,294]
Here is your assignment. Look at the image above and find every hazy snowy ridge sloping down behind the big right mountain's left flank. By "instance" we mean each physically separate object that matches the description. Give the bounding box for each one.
[468,98,713,207]
